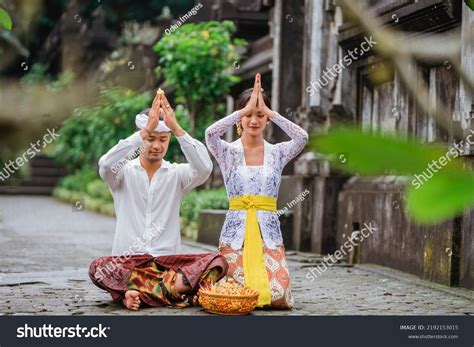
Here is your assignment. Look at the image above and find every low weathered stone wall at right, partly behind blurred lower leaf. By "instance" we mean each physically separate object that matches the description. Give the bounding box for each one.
[337,176,474,288]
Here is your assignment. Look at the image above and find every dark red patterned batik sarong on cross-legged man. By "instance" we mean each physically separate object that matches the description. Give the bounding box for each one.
[89,253,228,307]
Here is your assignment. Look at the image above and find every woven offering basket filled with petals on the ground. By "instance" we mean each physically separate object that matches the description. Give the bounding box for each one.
[199,278,258,316]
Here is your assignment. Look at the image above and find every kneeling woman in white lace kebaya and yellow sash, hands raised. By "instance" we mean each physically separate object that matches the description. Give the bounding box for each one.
[206,74,308,309]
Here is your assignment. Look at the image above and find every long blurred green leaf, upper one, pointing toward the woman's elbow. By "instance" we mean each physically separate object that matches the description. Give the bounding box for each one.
[311,127,461,176]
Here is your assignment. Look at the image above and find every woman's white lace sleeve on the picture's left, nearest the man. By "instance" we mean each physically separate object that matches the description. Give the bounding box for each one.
[206,111,240,166]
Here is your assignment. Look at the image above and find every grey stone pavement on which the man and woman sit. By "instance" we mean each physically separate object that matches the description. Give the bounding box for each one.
[0,196,474,315]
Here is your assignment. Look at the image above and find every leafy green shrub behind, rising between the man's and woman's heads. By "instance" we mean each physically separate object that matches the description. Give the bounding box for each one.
[153,21,244,138]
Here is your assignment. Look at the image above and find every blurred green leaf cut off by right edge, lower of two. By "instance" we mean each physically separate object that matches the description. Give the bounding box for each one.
[406,172,474,224]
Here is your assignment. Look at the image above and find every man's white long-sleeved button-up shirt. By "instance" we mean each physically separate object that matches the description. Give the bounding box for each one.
[99,132,212,256]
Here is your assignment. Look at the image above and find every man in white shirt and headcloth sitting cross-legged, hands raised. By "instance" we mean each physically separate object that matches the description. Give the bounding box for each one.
[89,90,227,310]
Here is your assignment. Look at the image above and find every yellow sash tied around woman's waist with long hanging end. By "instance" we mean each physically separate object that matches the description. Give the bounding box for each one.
[229,195,276,307]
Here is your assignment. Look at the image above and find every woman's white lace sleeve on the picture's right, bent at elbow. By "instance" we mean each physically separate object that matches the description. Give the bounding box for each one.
[271,112,308,167]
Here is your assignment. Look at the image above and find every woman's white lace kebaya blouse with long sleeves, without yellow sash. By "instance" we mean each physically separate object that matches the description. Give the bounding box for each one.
[206,111,308,249]
